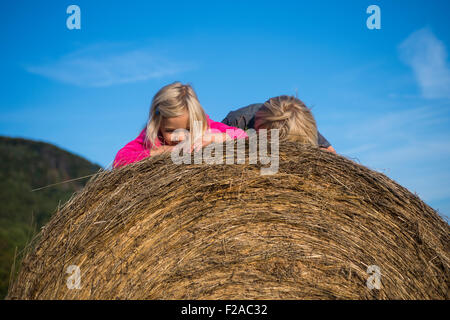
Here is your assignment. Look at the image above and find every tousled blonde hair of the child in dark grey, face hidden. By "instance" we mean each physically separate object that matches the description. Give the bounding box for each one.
[255,96,318,146]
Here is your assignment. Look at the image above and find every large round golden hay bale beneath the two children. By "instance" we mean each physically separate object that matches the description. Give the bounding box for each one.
[8,143,450,299]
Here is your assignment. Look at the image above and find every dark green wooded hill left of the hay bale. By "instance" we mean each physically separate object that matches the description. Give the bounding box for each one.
[0,136,101,298]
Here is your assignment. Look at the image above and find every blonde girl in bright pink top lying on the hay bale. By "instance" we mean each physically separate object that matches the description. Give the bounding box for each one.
[113,82,247,168]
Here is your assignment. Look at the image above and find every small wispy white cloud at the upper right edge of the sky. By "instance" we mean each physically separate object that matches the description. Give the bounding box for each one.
[398,28,450,99]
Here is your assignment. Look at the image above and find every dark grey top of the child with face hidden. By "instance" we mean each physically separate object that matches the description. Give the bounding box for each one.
[222,103,331,148]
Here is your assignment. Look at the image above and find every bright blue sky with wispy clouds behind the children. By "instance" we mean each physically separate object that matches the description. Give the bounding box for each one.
[0,0,450,216]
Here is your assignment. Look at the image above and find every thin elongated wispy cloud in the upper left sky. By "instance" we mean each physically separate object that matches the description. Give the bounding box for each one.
[26,45,191,87]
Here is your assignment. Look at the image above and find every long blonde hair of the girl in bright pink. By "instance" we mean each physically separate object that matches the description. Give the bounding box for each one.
[144,82,209,149]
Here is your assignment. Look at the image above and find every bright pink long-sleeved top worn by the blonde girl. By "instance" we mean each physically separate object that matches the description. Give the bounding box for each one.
[113,115,247,168]
